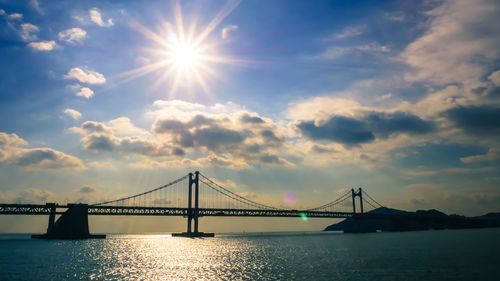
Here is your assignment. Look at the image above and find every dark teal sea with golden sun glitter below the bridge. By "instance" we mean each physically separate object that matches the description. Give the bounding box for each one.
[0,228,500,281]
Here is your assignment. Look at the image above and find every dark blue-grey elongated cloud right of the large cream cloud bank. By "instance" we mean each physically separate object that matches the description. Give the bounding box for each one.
[296,116,375,146]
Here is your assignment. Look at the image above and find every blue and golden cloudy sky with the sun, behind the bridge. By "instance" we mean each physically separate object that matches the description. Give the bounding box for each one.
[0,0,500,232]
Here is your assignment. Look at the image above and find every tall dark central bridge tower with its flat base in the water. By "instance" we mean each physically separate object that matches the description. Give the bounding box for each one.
[172,171,214,237]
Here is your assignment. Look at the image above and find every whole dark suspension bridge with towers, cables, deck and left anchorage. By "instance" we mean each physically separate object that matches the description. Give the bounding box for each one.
[0,171,382,238]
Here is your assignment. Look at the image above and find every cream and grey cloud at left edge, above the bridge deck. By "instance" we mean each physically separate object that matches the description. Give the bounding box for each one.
[0,132,85,170]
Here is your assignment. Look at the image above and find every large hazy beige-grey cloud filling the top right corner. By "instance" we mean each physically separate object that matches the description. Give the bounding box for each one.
[401,0,500,84]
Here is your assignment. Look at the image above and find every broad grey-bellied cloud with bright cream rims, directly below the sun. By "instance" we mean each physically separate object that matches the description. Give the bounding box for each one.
[73,112,294,169]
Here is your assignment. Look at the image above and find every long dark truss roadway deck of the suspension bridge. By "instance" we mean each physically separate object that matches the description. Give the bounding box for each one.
[0,204,359,218]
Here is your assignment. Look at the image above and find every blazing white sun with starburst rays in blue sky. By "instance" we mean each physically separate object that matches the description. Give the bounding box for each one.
[118,0,244,99]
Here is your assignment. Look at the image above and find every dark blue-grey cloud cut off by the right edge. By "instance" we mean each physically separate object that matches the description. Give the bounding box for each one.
[444,105,500,136]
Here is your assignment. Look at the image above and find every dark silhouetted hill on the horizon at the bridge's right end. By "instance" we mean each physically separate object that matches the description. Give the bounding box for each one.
[325,207,500,232]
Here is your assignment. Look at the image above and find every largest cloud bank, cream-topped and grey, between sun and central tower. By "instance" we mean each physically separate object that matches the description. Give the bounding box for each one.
[70,100,295,169]
